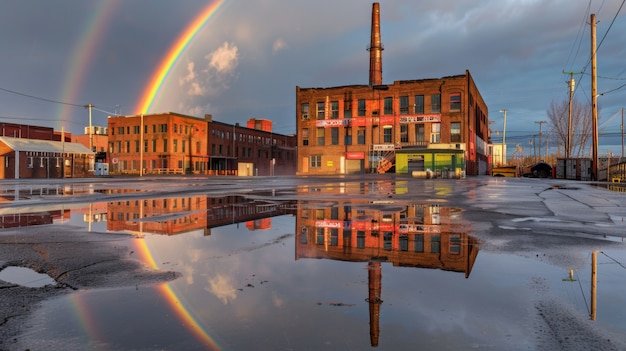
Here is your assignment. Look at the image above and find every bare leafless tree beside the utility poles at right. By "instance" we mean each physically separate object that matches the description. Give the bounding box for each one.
[547,99,592,157]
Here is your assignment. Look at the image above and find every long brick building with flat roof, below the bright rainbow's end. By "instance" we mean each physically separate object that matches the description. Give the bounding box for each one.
[108,112,296,176]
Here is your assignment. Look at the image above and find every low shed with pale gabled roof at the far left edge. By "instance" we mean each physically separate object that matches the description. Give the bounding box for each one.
[0,136,94,179]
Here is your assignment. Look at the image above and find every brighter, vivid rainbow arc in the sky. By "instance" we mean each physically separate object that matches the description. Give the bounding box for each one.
[135,0,225,114]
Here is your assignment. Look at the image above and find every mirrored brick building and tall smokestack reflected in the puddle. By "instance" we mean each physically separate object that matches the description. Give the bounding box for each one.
[296,201,478,346]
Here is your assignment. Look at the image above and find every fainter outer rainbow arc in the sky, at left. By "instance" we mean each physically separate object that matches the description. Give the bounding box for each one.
[59,1,119,129]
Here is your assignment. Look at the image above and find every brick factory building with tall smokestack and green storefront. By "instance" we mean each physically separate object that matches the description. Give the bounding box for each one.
[296,3,489,175]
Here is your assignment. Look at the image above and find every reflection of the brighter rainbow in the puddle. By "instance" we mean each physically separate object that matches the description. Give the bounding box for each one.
[135,239,221,350]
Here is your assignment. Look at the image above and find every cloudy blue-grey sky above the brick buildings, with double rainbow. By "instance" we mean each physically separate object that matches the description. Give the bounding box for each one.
[0,0,626,154]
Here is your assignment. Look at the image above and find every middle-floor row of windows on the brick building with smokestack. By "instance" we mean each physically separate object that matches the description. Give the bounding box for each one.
[301,122,461,146]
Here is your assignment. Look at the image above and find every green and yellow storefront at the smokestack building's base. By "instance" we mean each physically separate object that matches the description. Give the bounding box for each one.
[396,149,465,173]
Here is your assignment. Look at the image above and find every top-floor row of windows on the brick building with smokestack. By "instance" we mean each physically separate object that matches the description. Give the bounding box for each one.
[300,93,461,120]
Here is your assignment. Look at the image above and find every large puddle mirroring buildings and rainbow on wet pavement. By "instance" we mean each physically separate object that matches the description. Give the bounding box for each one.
[0,183,626,350]
